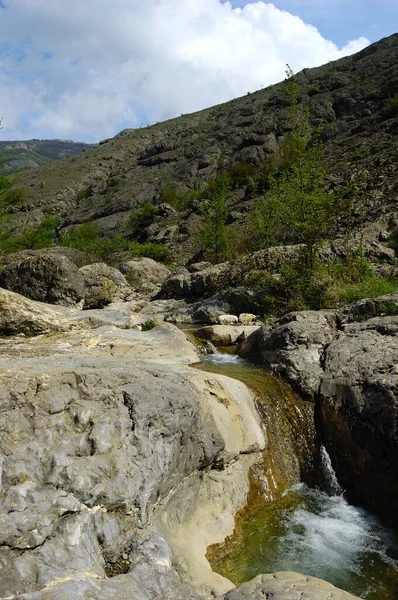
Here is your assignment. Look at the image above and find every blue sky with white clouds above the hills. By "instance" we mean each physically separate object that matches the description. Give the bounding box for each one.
[0,0,398,141]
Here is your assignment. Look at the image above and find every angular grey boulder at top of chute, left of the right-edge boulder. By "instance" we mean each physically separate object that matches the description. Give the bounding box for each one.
[239,310,337,399]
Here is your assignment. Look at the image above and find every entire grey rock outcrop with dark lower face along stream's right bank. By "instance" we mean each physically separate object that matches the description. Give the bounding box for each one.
[240,302,398,526]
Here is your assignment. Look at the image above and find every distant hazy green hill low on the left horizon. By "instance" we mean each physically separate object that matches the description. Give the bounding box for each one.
[0,140,93,175]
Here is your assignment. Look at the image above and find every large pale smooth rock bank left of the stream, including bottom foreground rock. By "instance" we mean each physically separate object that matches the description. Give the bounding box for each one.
[0,292,362,600]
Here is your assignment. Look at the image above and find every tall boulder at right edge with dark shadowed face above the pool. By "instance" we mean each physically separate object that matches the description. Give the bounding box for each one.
[319,317,398,525]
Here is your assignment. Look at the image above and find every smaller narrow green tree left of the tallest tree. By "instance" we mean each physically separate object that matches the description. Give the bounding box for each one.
[199,171,229,263]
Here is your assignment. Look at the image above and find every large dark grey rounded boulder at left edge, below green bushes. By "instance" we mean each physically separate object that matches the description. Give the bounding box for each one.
[0,250,85,306]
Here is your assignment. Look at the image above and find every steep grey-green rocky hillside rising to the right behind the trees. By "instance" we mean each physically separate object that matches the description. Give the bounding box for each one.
[3,34,398,264]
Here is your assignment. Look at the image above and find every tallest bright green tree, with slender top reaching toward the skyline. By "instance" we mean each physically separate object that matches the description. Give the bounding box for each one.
[256,67,336,269]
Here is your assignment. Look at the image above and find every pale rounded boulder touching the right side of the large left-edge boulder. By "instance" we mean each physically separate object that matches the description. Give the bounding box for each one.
[79,263,134,308]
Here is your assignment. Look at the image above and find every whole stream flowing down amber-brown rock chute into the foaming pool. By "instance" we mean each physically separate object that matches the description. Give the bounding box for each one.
[195,347,398,600]
